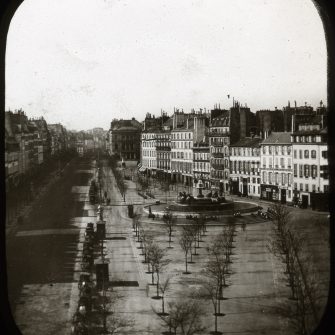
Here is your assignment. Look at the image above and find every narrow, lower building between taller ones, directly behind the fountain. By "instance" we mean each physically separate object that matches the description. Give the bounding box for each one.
[193,138,211,189]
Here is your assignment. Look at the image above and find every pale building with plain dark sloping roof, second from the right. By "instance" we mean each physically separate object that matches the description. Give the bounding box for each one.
[261,132,293,204]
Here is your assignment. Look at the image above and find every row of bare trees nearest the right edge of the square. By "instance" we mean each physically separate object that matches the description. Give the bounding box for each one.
[269,203,319,335]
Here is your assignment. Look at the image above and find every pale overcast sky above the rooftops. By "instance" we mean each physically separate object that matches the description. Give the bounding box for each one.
[6,0,327,130]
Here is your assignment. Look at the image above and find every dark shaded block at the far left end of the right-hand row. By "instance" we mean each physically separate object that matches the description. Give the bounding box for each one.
[109,118,142,161]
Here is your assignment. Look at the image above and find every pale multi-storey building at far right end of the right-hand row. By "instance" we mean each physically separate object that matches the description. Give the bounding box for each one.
[291,121,329,209]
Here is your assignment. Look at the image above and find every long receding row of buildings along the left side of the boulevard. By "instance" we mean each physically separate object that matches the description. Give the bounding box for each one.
[5,109,106,191]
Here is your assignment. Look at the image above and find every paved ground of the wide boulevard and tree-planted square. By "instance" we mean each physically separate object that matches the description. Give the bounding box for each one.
[7,160,329,335]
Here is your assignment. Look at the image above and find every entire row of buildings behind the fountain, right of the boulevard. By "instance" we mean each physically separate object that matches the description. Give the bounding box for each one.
[109,102,329,207]
